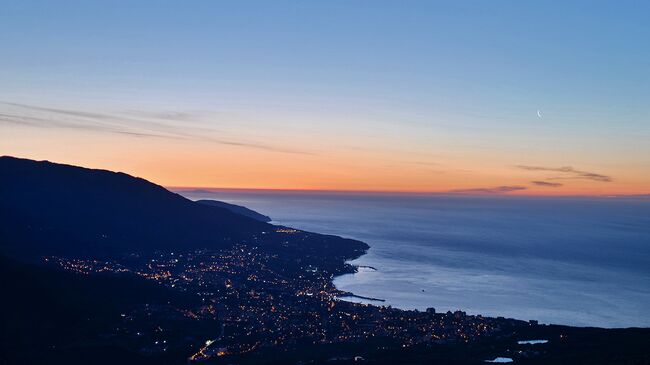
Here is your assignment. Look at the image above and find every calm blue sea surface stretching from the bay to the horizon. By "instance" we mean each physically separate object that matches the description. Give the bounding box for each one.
[177,191,650,327]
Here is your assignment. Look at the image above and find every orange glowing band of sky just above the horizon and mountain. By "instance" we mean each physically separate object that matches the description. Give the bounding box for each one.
[0,123,650,196]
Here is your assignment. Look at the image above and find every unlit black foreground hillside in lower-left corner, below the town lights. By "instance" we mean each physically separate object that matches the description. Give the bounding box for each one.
[0,256,205,364]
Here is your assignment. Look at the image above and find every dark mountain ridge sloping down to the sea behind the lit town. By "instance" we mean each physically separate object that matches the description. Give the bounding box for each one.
[0,156,368,260]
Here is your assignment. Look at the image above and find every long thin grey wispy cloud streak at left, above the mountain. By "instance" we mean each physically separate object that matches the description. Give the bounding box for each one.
[0,101,315,155]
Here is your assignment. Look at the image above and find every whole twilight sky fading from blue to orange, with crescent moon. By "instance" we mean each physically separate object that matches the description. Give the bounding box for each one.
[0,0,650,194]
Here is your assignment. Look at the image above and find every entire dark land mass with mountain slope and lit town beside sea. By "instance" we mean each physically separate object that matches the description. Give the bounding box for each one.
[0,157,650,364]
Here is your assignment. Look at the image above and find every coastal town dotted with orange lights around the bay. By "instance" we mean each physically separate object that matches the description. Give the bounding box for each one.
[44,232,536,361]
